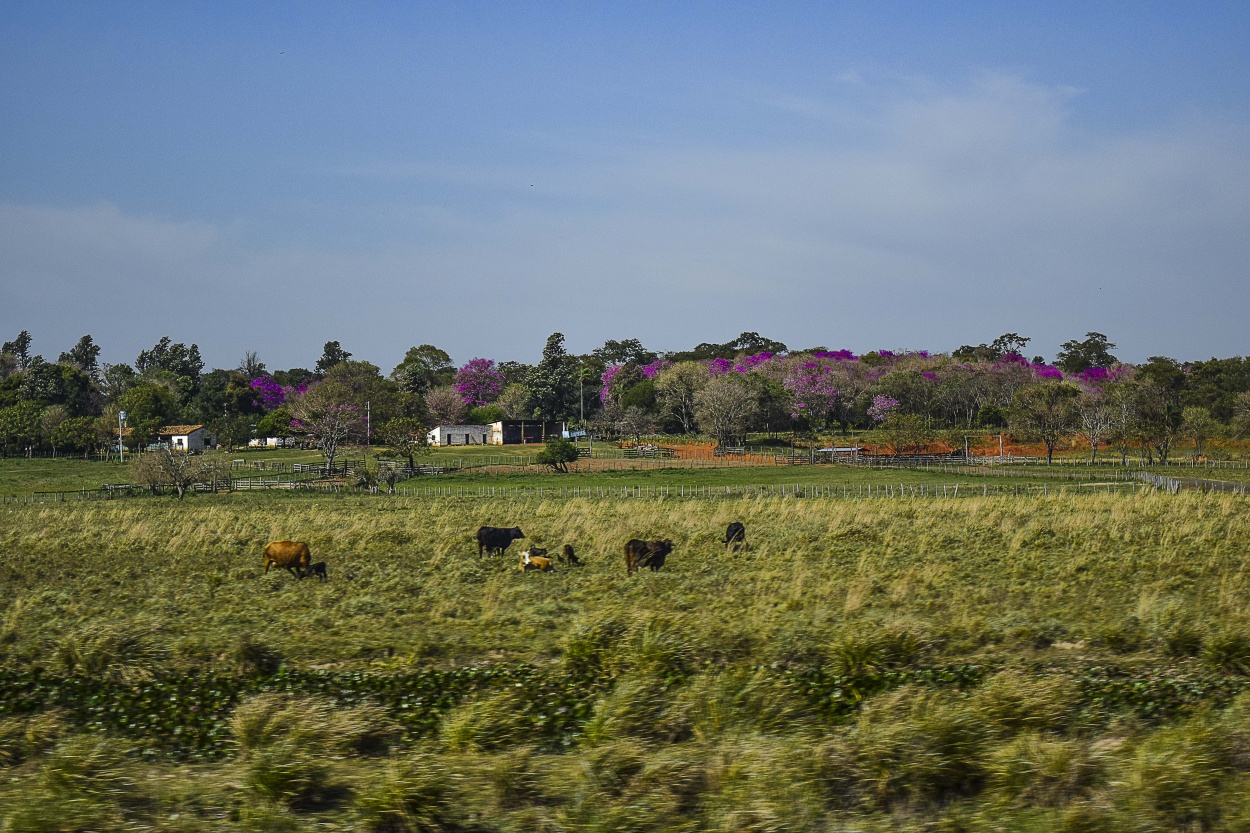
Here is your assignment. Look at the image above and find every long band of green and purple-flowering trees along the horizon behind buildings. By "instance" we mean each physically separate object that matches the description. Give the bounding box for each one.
[0,330,1250,464]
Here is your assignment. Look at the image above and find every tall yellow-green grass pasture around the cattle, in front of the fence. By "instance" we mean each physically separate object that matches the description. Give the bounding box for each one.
[0,494,1250,832]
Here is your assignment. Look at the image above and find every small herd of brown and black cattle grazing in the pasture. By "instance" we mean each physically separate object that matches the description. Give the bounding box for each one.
[255,520,748,582]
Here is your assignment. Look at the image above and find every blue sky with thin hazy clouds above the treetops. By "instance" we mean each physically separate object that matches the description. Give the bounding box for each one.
[0,1,1250,370]
